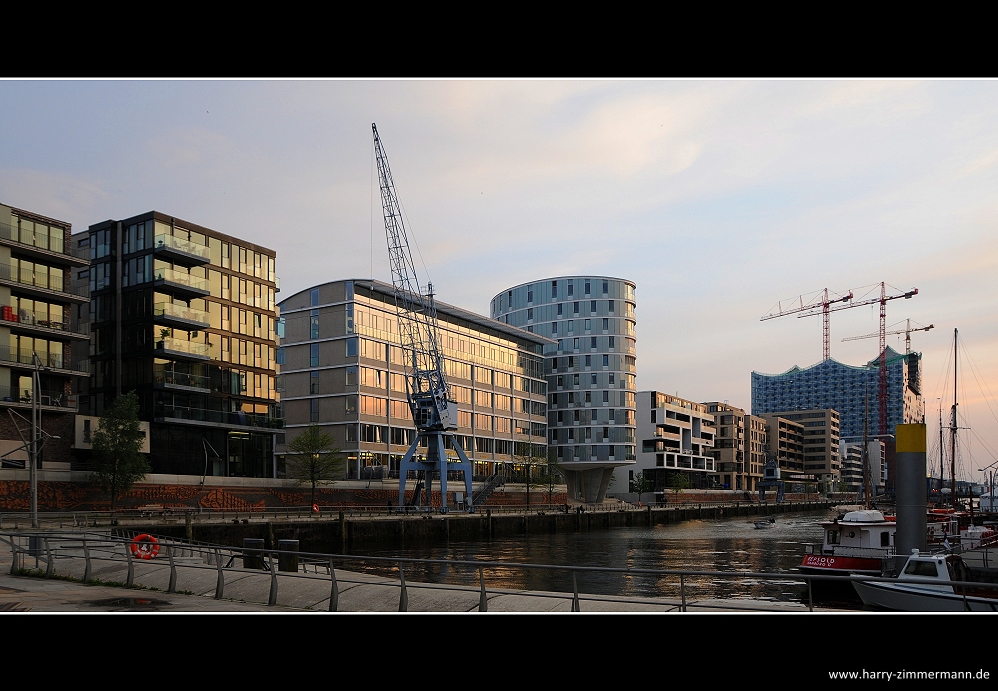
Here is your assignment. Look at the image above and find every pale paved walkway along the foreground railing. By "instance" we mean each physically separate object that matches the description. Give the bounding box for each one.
[0,544,844,613]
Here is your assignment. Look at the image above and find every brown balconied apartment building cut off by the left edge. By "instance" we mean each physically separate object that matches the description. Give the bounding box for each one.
[0,204,88,471]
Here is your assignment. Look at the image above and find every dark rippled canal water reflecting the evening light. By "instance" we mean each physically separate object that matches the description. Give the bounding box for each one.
[343,510,852,602]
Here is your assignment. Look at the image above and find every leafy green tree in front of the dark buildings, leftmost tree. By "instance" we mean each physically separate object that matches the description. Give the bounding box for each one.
[91,391,149,511]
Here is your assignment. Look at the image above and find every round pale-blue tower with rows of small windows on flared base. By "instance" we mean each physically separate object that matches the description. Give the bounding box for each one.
[491,276,636,503]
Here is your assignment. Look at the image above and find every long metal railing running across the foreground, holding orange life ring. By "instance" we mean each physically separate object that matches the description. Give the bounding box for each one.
[0,531,998,612]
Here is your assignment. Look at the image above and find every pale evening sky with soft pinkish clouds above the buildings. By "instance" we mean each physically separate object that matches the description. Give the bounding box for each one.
[0,80,998,480]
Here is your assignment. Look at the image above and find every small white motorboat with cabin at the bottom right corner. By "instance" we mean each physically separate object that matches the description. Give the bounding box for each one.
[853,550,998,612]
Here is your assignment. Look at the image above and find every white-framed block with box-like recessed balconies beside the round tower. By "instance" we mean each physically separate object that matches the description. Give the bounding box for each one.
[628,391,719,495]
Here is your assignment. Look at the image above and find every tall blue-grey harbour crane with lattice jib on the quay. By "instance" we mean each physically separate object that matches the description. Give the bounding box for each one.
[371,123,472,511]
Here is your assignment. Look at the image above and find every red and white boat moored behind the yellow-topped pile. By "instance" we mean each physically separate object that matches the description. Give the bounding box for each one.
[800,509,897,593]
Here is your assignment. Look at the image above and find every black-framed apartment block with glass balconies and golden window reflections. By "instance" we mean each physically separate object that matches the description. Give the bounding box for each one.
[72,211,283,478]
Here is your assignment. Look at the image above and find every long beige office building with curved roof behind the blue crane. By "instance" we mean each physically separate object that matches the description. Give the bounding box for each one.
[279,280,554,478]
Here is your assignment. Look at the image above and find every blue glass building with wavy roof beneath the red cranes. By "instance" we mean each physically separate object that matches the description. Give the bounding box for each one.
[752,347,923,439]
